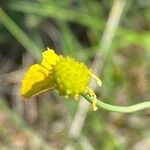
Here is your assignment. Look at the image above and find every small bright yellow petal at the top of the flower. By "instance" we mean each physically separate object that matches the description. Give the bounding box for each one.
[41,48,59,71]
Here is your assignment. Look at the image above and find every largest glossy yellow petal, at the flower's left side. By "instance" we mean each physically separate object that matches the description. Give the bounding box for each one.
[21,64,54,98]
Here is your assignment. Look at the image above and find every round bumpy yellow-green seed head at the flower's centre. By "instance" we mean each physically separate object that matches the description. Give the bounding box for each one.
[54,57,91,97]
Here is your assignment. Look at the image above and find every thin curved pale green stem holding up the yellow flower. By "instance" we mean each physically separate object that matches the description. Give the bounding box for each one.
[82,94,150,113]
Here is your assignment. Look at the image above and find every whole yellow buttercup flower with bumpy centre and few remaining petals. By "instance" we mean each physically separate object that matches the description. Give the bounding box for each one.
[21,48,101,110]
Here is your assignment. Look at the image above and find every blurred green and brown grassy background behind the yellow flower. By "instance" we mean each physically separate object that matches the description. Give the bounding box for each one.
[0,0,150,150]
